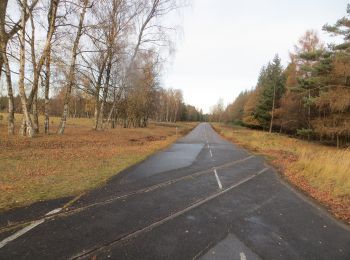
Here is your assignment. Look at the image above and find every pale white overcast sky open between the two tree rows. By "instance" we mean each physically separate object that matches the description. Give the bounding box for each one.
[163,0,349,112]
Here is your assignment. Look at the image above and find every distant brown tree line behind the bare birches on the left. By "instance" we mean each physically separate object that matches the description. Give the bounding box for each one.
[0,87,206,128]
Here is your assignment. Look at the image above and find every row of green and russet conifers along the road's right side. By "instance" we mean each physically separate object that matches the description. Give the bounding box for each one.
[213,5,350,147]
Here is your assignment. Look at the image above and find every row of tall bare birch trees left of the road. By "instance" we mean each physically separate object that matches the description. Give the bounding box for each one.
[0,0,204,137]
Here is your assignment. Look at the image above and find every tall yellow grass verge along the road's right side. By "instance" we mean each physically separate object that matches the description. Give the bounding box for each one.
[214,124,350,223]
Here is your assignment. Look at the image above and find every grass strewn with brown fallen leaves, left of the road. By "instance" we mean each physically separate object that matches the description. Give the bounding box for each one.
[0,114,195,211]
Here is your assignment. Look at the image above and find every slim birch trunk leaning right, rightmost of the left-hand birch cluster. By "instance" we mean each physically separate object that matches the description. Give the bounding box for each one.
[57,0,89,134]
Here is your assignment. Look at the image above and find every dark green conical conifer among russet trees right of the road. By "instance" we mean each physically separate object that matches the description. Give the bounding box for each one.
[254,55,285,129]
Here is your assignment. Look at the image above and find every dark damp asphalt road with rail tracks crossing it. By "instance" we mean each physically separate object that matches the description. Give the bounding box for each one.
[0,123,350,260]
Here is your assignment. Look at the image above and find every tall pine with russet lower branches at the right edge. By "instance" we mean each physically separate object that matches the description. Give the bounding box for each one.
[312,4,350,147]
